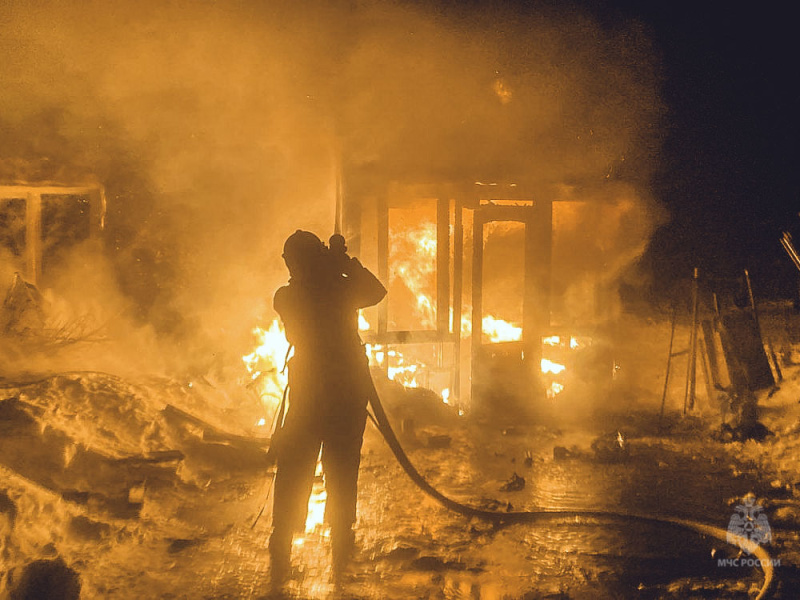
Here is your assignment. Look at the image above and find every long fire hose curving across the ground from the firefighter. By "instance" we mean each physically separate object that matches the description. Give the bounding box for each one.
[368,384,774,600]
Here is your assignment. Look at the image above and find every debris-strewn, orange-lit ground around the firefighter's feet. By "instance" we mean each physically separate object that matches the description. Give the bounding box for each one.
[0,308,800,599]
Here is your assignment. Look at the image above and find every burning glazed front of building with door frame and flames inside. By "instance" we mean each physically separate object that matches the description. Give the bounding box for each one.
[334,177,647,419]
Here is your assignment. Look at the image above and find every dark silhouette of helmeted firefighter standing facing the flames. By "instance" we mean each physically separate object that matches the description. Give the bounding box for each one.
[269,230,386,582]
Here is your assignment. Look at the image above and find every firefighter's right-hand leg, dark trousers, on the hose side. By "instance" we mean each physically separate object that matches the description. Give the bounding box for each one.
[322,413,366,568]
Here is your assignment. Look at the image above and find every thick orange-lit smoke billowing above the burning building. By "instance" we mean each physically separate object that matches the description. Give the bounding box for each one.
[0,0,662,372]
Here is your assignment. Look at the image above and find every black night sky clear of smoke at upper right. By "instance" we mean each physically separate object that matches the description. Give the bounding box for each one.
[590,0,800,296]
